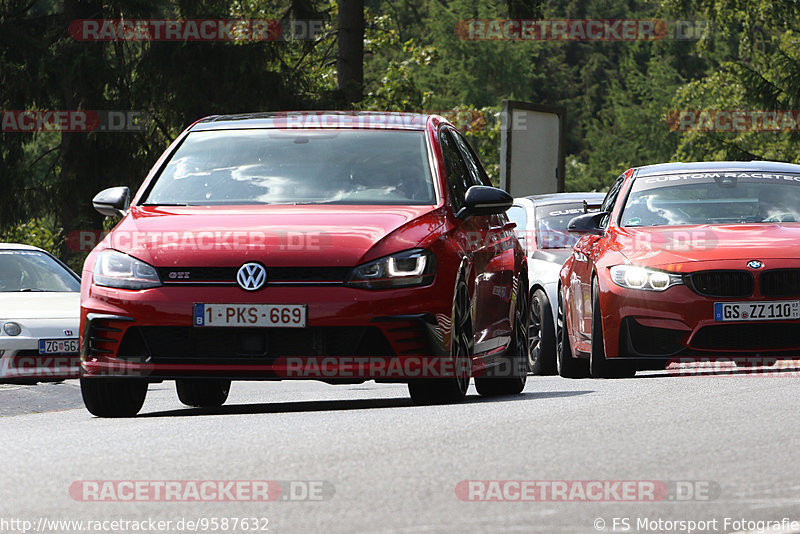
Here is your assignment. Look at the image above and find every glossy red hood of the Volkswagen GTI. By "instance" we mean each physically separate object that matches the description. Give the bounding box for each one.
[103,205,442,267]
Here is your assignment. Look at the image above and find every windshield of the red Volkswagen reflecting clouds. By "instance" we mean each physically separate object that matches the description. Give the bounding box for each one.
[143,129,436,205]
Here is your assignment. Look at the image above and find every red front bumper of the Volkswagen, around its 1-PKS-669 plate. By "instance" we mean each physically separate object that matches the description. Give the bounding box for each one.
[81,286,452,382]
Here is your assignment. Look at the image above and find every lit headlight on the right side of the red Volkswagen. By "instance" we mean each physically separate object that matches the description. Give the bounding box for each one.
[346,249,436,289]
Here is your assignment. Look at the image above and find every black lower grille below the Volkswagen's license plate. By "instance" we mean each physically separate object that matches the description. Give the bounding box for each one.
[117,326,394,364]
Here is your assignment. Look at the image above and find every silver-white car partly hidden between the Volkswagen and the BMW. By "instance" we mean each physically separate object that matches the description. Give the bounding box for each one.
[506,193,605,375]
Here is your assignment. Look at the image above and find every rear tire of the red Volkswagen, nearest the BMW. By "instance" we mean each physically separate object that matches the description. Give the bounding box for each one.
[475,280,530,397]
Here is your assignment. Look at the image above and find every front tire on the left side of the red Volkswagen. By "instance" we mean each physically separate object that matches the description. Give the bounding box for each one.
[81,378,147,417]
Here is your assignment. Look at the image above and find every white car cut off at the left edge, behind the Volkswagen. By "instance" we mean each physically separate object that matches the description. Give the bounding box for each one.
[0,243,81,383]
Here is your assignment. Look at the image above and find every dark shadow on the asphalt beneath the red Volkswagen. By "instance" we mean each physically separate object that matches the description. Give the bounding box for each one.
[138,391,593,417]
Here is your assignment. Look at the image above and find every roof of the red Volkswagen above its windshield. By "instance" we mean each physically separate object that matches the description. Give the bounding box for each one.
[190,111,434,131]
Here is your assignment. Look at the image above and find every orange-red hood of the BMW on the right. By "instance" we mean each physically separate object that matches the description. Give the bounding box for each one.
[611,224,800,271]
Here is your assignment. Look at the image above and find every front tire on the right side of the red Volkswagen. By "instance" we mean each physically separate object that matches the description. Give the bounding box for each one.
[408,280,475,405]
